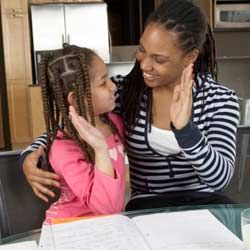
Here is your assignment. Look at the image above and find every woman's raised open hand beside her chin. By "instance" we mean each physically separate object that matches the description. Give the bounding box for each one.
[170,64,193,129]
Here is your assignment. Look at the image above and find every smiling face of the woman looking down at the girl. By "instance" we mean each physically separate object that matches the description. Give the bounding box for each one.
[136,23,188,88]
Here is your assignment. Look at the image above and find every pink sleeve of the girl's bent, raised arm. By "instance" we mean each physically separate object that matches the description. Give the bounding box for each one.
[50,140,125,214]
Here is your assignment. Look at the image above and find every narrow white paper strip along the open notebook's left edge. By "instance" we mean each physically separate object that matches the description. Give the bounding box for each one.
[38,225,55,250]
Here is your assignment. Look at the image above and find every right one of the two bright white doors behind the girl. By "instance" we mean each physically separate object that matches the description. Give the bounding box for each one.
[65,3,110,63]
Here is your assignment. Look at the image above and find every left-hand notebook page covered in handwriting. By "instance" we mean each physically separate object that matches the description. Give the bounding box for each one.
[52,215,149,250]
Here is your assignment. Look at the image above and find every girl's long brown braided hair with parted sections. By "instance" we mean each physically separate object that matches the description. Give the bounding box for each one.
[39,44,121,166]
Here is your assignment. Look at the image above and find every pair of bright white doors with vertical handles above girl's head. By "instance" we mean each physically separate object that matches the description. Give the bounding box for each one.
[31,3,110,63]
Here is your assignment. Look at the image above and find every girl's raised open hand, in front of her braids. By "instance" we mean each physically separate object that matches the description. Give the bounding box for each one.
[69,106,107,151]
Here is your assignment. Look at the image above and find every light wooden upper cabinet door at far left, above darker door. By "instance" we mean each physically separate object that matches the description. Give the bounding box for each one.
[2,13,32,80]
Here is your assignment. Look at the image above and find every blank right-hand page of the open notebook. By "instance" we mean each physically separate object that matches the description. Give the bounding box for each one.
[132,210,244,250]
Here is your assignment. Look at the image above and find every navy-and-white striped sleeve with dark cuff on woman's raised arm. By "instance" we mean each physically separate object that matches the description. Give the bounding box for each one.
[173,91,239,191]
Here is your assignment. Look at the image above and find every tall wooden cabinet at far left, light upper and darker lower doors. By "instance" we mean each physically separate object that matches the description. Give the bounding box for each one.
[1,0,32,144]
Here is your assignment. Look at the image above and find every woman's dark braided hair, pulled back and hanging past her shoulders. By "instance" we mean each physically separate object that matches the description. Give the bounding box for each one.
[121,0,217,128]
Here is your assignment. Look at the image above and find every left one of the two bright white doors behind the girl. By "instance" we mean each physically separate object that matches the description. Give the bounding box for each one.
[31,4,66,51]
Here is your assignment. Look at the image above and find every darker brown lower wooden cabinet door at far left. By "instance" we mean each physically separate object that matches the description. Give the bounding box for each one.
[7,80,31,144]
